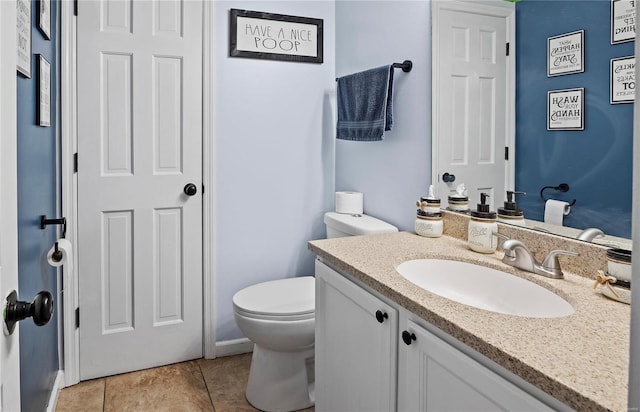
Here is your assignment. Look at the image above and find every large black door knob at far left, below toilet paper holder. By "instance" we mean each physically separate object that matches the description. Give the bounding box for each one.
[4,290,53,334]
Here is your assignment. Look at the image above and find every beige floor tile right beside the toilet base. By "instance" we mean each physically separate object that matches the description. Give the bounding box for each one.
[198,353,257,412]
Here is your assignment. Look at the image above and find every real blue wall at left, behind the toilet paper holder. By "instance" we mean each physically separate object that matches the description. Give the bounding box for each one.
[17,1,59,411]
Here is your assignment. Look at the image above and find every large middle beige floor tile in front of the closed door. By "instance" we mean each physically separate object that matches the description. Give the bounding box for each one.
[104,361,213,412]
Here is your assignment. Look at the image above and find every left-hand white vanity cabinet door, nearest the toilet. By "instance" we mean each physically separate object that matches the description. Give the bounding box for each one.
[315,261,398,412]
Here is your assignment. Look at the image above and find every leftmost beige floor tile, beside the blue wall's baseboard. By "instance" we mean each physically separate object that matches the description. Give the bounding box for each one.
[56,378,106,412]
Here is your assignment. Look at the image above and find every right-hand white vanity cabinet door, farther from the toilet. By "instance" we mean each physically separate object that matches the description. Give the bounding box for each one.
[398,320,551,412]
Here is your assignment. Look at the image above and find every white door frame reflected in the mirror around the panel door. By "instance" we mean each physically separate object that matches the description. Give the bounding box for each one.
[431,0,516,193]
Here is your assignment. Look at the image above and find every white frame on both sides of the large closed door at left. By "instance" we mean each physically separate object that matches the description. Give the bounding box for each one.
[62,0,216,386]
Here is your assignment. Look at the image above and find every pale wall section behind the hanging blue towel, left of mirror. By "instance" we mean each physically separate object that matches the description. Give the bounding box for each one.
[336,0,431,230]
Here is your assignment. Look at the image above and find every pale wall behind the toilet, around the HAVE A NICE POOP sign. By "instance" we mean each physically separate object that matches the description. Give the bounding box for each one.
[214,1,335,341]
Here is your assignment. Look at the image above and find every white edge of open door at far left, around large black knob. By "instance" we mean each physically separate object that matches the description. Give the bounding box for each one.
[0,1,20,411]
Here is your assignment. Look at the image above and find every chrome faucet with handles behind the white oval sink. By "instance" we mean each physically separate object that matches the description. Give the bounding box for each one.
[500,239,578,279]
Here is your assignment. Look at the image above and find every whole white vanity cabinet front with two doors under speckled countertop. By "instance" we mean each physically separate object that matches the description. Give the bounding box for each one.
[315,261,568,412]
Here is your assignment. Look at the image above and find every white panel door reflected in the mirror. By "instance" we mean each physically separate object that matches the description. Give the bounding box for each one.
[433,2,509,210]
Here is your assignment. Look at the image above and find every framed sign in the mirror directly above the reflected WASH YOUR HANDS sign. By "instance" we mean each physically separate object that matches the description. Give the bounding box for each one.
[547,30,584,77]
